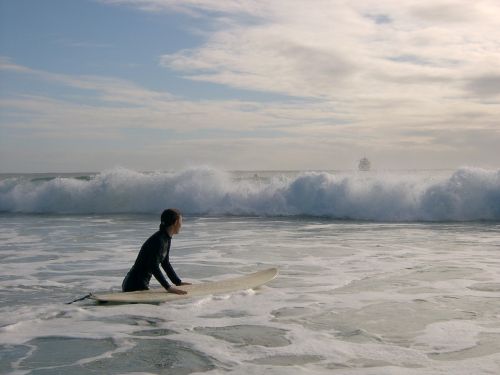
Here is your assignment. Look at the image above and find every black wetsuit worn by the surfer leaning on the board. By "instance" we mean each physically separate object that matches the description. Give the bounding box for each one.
[122,231,182,292]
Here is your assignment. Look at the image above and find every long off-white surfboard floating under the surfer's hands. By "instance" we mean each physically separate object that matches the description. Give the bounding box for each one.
[90,268,278,303]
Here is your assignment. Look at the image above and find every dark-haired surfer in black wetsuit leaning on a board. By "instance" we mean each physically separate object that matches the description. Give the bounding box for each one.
[122,208,190,294]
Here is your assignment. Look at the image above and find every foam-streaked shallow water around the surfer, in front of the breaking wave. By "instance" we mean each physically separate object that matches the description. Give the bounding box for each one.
[0,213,500,375]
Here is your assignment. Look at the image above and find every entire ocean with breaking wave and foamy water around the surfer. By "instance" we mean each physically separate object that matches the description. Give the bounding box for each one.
[0,168,500,375]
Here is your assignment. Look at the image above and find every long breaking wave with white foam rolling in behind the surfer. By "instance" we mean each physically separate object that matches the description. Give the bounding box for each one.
[0,167,500,222]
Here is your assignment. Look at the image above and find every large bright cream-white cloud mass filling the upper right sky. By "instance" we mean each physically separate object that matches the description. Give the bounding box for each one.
[153,0,500,160]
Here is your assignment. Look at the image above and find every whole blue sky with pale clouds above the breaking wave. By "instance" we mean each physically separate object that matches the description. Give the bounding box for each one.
[0,0,500,173]
